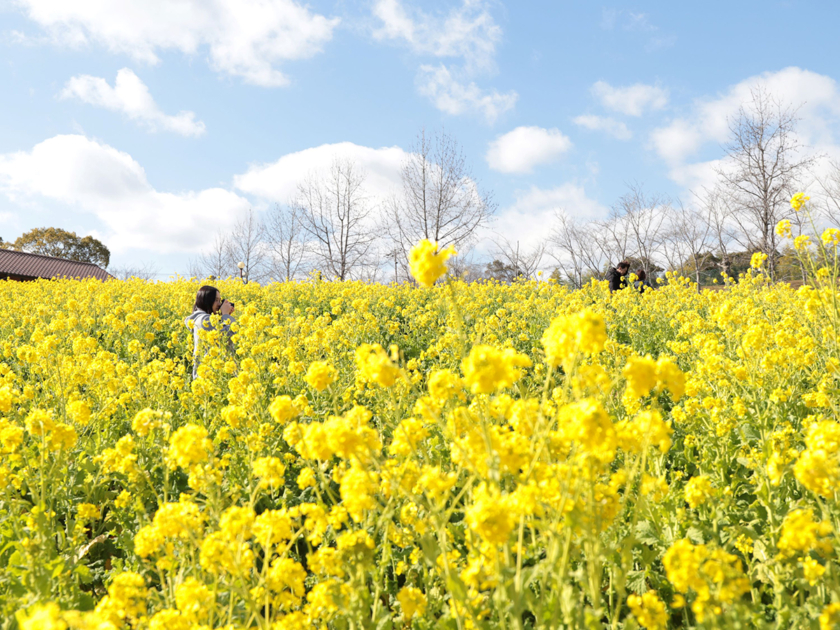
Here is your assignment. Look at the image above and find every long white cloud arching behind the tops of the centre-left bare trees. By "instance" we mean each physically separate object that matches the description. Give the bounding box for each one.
[234,142,408,203]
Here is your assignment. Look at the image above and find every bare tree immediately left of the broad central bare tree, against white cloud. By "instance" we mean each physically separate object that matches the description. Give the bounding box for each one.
[293,159,376,280]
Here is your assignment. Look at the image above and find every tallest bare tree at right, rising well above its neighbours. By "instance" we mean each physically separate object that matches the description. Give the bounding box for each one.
[718,87,814,278]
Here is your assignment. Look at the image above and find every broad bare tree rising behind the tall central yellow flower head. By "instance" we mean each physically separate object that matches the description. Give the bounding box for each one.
[387,130,496,260]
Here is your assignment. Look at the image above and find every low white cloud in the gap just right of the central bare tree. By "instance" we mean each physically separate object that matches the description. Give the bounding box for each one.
[492,182,608,251]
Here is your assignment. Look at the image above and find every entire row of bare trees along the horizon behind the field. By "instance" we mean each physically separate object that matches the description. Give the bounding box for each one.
[191,88,840,287]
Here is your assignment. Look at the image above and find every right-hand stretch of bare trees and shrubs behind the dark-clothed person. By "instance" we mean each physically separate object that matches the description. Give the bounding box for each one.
[549,87,840,286]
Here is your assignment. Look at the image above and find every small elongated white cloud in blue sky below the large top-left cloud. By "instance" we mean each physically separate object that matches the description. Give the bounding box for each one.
[61,68,206,136]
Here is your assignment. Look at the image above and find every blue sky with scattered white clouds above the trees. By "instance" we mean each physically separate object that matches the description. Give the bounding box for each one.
[0,0,840,276]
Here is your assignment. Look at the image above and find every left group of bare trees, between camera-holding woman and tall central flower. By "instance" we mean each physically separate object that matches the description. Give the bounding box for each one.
[189,131,496,281]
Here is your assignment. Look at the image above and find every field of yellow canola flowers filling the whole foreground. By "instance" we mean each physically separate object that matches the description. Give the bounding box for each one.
[0,218,840,630]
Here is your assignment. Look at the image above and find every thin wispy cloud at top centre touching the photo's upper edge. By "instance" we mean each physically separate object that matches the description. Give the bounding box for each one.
[373,0,502,69]
